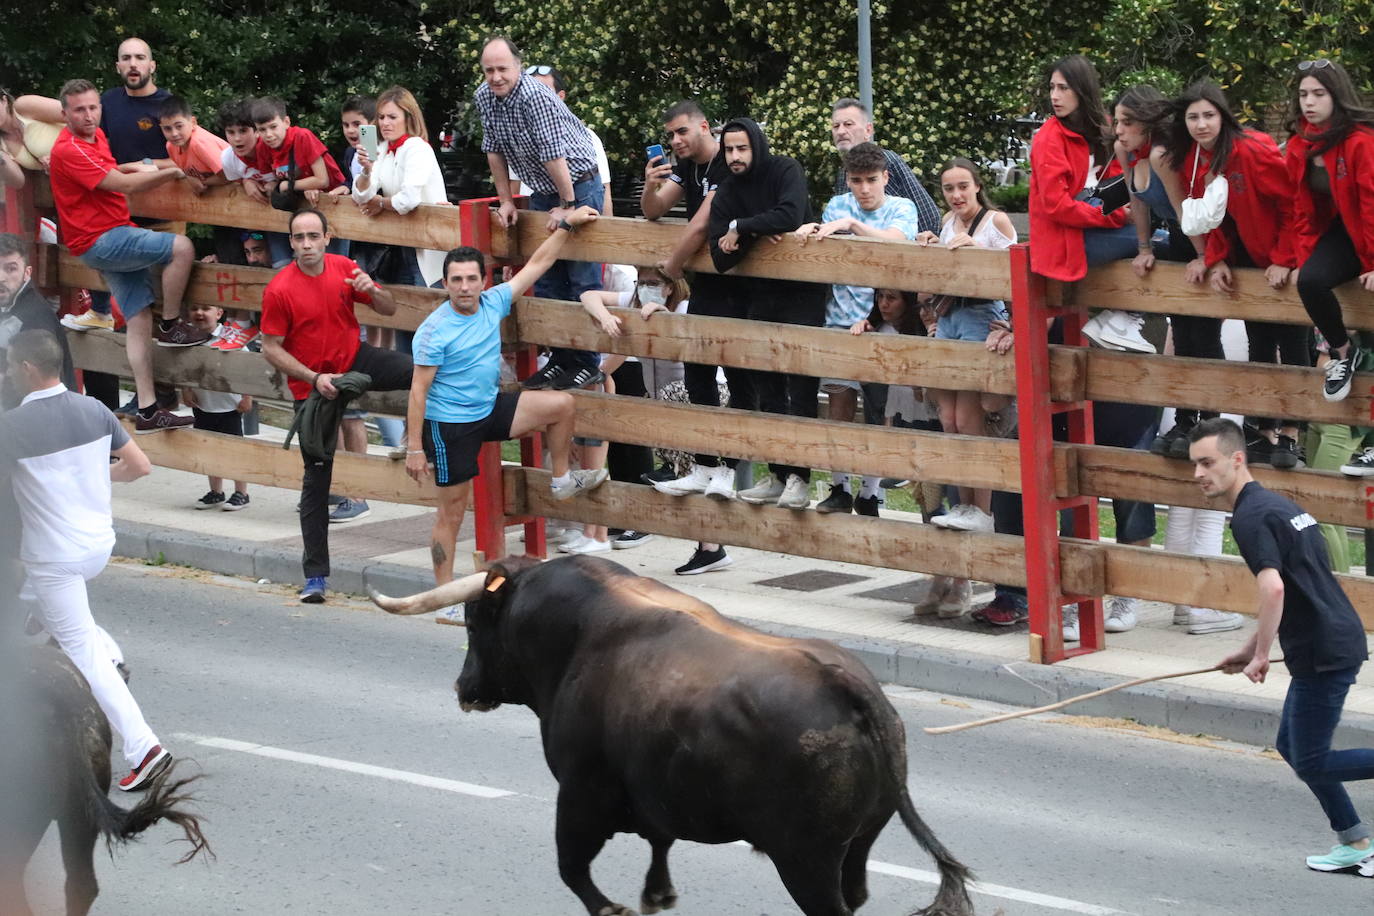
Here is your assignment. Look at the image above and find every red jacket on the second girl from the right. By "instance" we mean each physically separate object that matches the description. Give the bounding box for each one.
[1179,130,1297,268]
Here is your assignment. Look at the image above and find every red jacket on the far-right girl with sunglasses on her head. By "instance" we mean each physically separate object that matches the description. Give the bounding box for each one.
[1287,125,1374,273]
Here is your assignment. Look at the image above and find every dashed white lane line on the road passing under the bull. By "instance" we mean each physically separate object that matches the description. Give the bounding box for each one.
[176,733,1127,916]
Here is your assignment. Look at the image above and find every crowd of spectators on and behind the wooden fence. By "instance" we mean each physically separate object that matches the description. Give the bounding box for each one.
[0,36,1374,640]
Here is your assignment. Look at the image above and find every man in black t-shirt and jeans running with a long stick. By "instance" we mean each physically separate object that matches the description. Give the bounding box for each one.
[1189,419,1374,878]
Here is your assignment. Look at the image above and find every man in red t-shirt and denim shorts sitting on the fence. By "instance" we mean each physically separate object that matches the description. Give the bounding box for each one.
[49,80,210,433]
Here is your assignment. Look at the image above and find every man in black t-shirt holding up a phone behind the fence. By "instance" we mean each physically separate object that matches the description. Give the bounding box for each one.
[639,102,752,575]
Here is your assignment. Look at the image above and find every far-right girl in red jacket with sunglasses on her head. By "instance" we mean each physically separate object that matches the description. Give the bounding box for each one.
[1287,59,1374,401]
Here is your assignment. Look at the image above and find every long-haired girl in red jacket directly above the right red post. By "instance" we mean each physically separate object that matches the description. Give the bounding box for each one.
[1031,54,1154,353]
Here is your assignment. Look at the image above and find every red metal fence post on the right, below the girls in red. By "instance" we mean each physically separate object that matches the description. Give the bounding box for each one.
[1011,244,1103,663]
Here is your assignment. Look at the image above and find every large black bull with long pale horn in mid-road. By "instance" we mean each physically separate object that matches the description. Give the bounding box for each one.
[374,558,971,916]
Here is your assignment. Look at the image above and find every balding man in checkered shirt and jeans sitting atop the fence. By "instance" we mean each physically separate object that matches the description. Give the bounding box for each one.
[474,36,605,389]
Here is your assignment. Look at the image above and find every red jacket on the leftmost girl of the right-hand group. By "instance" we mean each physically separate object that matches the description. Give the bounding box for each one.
[1031,118,1128,280]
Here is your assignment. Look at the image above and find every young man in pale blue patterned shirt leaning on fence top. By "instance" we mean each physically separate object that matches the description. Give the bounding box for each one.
[796,143,919,515]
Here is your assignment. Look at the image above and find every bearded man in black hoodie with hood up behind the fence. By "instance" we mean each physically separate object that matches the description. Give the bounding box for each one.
[706,118,826,509]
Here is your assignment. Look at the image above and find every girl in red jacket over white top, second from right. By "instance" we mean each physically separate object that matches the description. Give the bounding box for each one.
[1169,80,1312,468]
